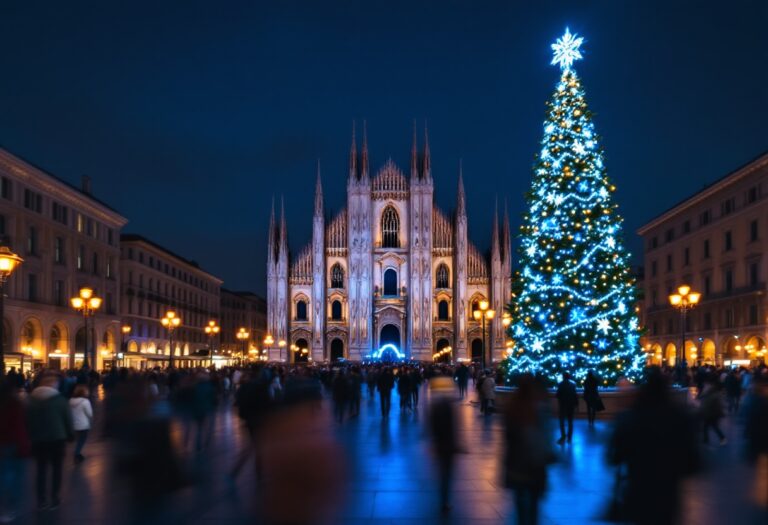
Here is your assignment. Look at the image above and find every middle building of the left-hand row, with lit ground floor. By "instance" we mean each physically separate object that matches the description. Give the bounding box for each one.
[120,234,222,368]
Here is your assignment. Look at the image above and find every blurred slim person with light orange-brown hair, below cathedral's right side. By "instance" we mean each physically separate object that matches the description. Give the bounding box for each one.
[429,376,460,514]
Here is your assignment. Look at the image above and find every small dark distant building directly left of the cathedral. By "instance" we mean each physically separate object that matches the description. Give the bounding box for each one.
[216,288,267,359]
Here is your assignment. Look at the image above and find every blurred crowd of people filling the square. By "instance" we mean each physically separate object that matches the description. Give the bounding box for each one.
[0,363,768,524]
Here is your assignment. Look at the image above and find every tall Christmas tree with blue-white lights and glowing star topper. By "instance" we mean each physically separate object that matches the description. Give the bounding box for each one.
[502,29,645,385]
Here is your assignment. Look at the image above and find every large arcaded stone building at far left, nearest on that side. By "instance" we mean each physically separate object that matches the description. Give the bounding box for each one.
[0,149,127,369]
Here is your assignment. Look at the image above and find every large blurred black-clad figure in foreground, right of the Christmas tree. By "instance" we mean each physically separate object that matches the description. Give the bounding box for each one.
[608,369,699,525]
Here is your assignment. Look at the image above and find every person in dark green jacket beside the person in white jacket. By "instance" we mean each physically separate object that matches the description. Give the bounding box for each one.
[27,374,75,510]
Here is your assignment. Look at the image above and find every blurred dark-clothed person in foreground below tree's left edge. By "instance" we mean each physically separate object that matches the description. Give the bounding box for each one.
[501,374,556,525]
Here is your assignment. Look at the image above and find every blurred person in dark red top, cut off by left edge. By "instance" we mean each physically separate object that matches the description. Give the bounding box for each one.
[0,378,30,523]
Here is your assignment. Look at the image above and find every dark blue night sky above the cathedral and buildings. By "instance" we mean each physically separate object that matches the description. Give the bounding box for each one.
[0,0,768,292]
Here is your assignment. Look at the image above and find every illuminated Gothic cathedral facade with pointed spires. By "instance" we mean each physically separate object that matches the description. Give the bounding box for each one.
[264,126,512,362]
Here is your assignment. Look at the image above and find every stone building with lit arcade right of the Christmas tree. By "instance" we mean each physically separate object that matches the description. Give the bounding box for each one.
[638,150,768,364]
